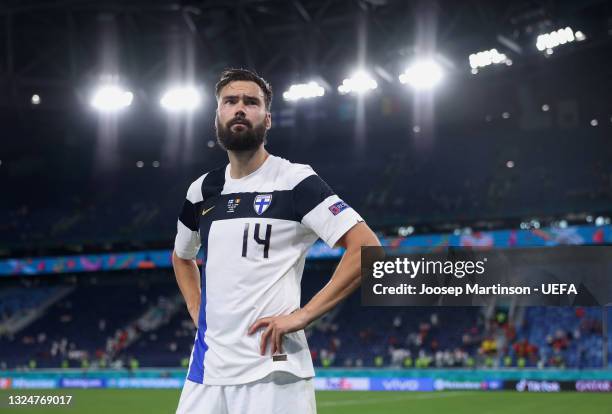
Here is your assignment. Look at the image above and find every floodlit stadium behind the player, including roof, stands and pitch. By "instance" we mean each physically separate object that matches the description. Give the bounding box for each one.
[0,0,612,414]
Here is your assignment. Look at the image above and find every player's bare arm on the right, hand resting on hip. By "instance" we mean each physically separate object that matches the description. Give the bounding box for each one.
[248,223,380,355]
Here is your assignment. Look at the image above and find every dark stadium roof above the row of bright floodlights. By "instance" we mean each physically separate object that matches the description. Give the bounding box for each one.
[0,0,612,107]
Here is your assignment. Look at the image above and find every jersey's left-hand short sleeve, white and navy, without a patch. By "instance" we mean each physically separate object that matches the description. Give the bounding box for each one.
[174,175,205,260]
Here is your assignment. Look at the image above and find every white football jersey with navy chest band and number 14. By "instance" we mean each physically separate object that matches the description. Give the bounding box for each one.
[175,155,363,385]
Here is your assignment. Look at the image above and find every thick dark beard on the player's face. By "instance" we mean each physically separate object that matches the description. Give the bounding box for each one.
[215,117,267,152]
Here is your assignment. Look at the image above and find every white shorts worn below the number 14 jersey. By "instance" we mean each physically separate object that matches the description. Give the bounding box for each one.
[176,371,317,414]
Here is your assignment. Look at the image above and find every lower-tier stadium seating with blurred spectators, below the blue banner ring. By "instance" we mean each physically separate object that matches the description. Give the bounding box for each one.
[0,268,612,368]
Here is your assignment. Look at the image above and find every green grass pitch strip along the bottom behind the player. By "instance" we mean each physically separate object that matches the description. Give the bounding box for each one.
[0,390,612,414]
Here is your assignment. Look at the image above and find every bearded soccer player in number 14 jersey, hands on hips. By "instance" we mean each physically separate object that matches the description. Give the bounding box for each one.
[172,69,380,414]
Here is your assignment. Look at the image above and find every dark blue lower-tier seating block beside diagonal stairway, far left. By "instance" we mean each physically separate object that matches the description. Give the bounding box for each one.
[0,272,177,367]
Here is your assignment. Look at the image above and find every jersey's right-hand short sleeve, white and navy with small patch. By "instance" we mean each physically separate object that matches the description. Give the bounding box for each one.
[293,172,363,247]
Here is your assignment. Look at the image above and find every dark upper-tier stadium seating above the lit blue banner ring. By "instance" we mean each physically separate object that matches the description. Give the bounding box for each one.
[0,106,612,252]
